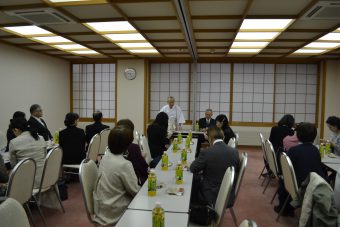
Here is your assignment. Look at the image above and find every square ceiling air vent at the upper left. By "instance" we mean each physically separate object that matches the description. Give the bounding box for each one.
[6,8,75,25]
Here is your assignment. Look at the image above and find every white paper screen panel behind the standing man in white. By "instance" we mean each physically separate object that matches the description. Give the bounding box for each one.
[150,63,190,120]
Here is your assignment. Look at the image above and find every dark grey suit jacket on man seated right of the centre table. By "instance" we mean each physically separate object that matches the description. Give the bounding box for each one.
[190,142,240,204]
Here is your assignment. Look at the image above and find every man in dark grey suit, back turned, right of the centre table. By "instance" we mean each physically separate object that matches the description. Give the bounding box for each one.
[190,126,240,205]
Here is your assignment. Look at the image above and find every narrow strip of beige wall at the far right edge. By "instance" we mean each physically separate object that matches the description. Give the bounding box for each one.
[323,60,340,138]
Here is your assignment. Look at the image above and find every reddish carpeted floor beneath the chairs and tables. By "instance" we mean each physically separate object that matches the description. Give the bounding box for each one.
[29,148,298,227]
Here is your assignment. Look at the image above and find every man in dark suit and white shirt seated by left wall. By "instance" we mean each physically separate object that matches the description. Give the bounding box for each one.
[28,104,53,141]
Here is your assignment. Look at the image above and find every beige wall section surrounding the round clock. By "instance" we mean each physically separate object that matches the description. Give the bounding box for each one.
[117,60,146,133]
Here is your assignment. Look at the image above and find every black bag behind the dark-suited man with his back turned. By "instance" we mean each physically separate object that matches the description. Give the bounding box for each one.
[189,204,217,226]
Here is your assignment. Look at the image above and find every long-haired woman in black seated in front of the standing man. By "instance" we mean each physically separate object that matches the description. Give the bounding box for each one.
[147,112,169,168]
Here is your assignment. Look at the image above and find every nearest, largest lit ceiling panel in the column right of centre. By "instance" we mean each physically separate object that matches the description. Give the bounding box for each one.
[240,19,293,31]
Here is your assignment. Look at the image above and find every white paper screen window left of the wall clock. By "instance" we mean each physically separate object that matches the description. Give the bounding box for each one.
[72,64,116,119]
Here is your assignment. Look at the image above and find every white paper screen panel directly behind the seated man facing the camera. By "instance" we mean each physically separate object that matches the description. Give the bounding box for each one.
[196,63,230,119]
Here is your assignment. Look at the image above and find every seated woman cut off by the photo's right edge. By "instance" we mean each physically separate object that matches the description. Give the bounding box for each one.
[321,116,340,155]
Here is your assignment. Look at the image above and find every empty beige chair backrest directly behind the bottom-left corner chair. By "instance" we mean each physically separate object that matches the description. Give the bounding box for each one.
[6,158,36,204]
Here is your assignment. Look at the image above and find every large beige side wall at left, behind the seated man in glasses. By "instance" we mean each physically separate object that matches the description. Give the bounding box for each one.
[0,44,70,133]
